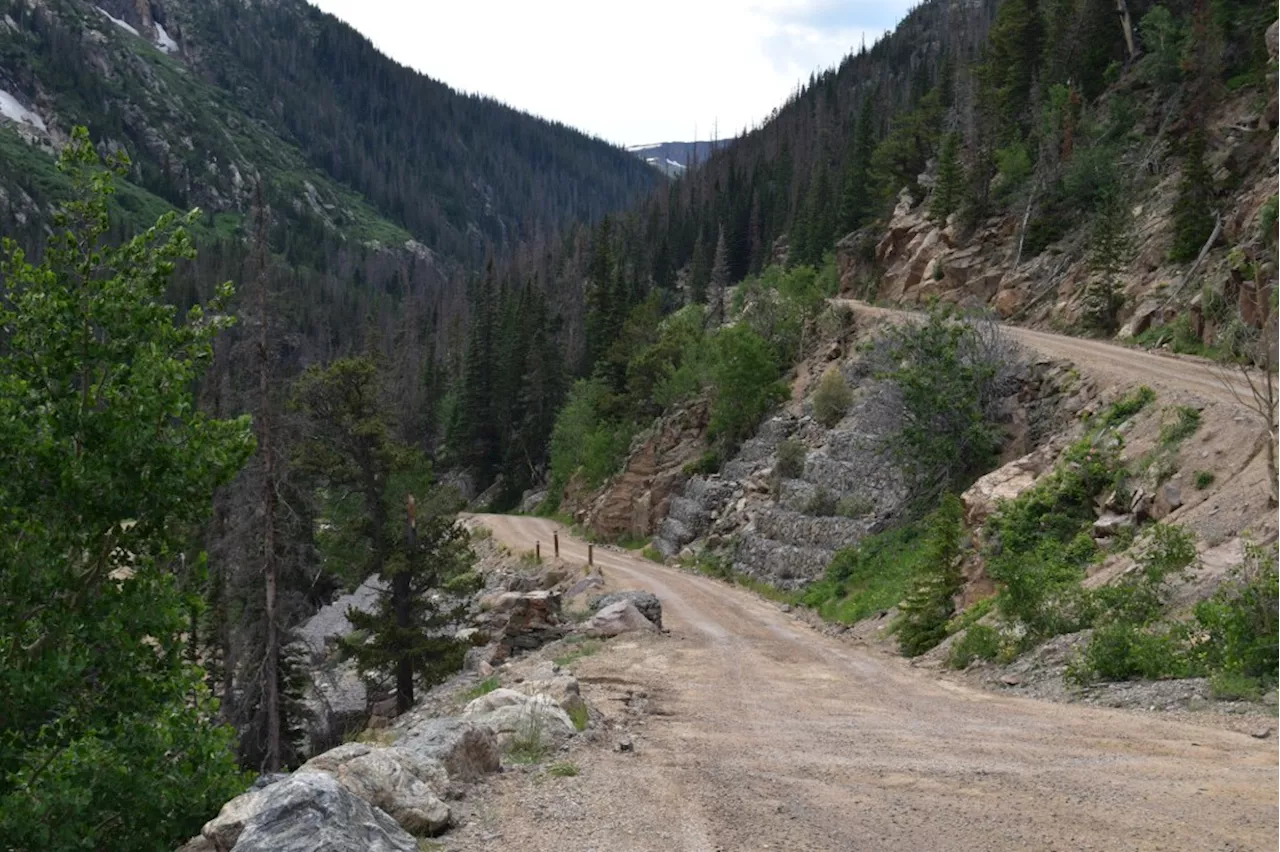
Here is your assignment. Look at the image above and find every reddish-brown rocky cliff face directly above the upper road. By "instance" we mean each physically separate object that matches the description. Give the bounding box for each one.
[837,75,1280,345]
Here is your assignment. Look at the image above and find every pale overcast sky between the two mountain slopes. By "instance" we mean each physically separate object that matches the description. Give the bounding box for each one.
[311,0,911,145]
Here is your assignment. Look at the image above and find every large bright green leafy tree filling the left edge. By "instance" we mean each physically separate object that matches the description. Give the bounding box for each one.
[0,129,253,851]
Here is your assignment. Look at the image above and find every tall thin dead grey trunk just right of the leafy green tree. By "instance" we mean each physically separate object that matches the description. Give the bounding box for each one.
[256,184,283,773]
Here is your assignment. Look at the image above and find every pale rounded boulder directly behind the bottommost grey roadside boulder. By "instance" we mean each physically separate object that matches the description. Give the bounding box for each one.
[298,743,449,835]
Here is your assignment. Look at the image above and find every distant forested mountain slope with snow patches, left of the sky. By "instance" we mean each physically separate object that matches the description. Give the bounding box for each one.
[0,0,658,262]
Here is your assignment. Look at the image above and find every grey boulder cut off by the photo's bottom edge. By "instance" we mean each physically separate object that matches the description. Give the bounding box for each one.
[227,773,419,852]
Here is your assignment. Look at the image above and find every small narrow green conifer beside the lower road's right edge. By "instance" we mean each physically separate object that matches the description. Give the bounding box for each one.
[896,495,964,656]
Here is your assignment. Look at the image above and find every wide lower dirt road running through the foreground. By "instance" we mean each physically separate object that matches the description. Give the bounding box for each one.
[466,516,1280,852]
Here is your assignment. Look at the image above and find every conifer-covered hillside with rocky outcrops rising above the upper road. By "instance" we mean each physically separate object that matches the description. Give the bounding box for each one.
[461,0,1275,504]
